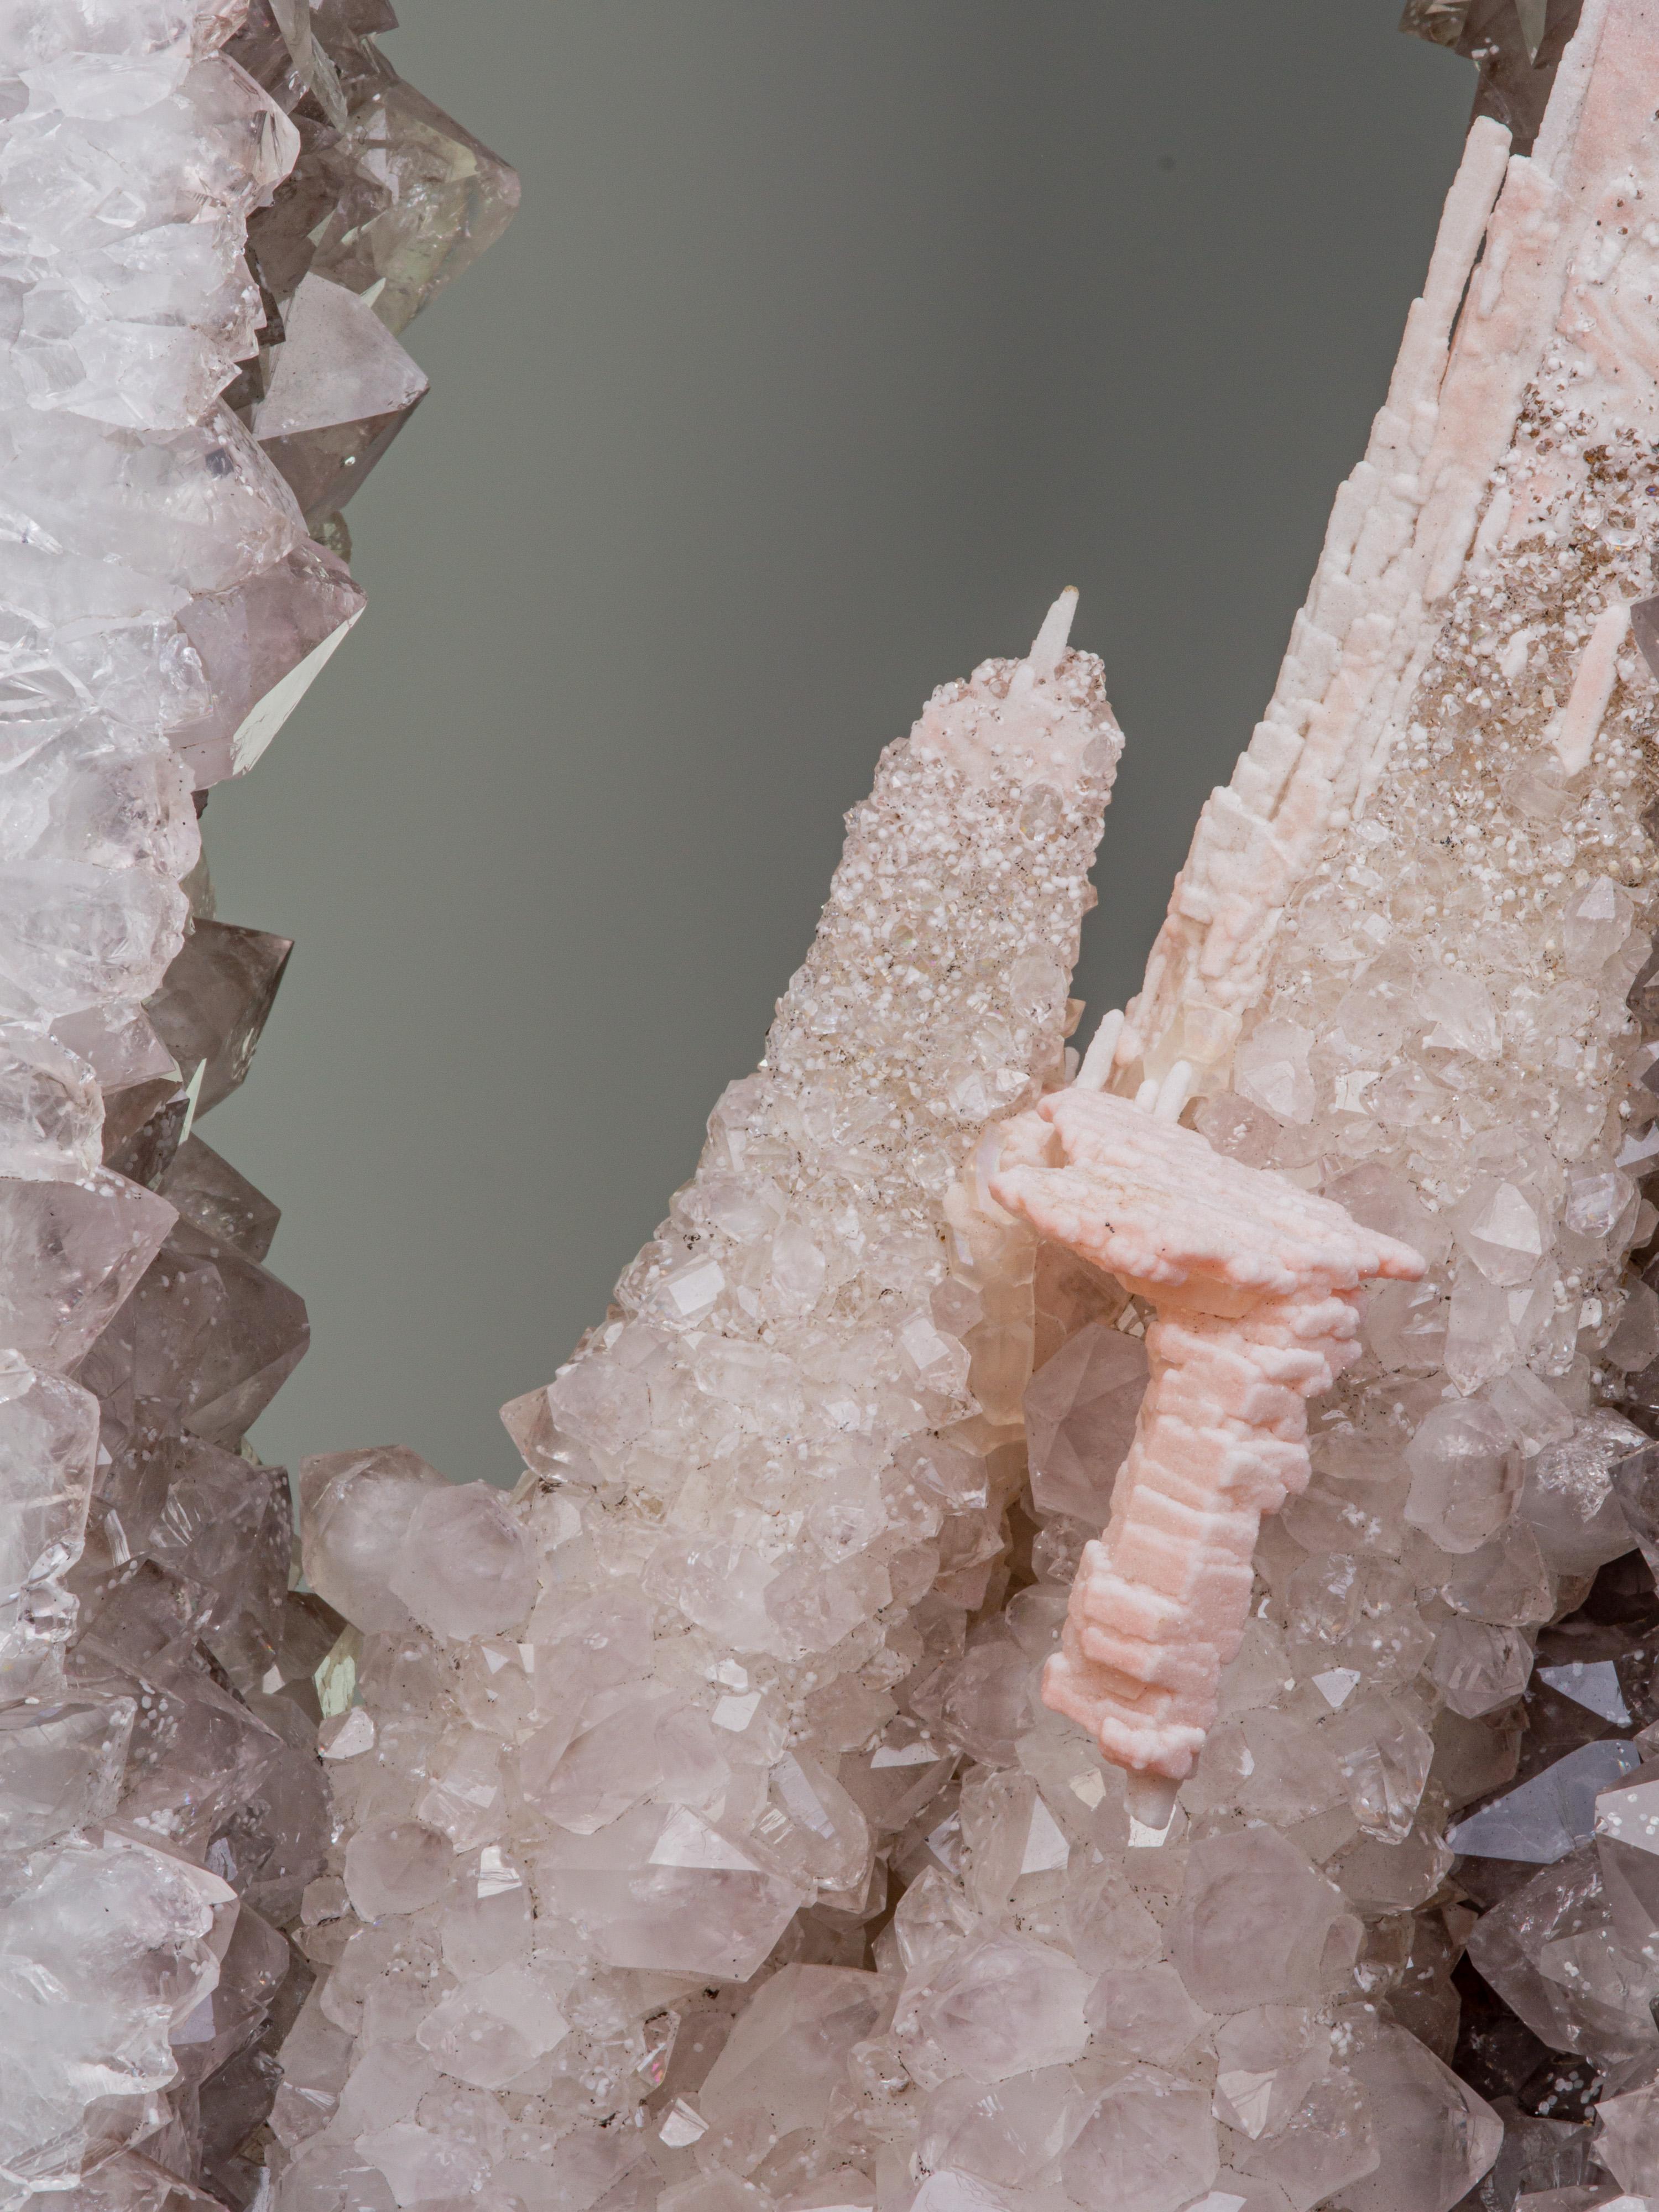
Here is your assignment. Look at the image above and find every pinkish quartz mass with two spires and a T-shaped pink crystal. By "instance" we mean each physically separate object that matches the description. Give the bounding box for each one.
[272,13,1659,2212]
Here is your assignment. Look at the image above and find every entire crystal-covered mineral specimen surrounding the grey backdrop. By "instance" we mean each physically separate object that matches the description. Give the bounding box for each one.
[16,0,1659,2212]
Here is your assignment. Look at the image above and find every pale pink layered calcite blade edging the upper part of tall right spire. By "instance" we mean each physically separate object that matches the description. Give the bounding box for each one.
[1117,0,1659,1091]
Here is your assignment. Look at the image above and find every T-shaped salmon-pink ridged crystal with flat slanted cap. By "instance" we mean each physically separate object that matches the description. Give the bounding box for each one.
[991,1088,1422,1820]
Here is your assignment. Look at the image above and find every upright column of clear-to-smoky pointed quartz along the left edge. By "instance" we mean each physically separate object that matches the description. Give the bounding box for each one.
[0,0,511,2212]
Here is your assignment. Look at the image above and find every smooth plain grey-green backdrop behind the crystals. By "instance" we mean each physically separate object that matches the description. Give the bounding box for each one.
[204,0,1471,1480]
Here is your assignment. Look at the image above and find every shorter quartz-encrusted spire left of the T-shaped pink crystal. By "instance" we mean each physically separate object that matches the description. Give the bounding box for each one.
[283,619,1119,2208]
